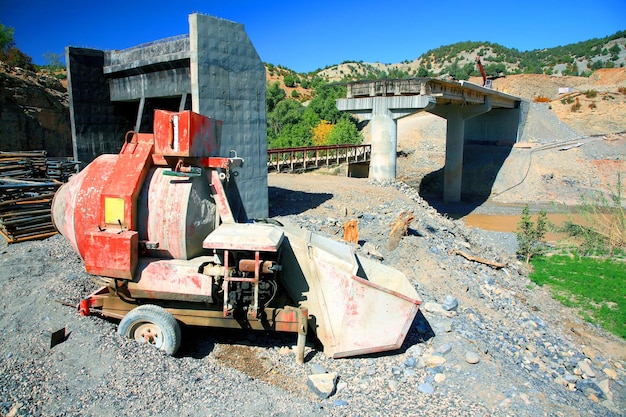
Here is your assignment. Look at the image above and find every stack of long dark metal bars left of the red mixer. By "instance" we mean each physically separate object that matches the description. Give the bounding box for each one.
[0,151,79,243]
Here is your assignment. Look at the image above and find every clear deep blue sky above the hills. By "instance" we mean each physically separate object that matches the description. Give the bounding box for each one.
[0,0,626,72]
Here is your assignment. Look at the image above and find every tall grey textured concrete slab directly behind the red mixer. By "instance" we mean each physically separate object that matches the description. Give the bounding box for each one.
[189,14,269,218]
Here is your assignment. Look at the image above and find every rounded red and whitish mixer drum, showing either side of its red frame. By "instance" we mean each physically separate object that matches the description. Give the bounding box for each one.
[52,155,216,259]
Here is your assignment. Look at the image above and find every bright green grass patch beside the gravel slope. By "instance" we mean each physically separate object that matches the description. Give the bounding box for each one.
[530,255,626,339]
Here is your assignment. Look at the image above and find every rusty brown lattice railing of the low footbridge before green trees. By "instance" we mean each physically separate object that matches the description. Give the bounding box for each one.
[267,145,372,172]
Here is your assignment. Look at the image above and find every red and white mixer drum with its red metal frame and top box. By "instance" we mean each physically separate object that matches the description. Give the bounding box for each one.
[53,110,224,279]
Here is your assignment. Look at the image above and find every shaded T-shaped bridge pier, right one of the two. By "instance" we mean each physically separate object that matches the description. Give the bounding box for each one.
[430,96,491,203]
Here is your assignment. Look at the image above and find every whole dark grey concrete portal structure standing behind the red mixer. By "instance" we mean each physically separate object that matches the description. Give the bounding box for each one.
[66,14,269,218]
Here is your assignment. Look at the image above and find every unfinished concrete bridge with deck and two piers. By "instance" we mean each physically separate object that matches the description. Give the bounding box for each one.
[337,78,522,202]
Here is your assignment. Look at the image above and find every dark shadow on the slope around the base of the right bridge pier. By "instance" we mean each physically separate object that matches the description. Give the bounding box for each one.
[419,144,523,219]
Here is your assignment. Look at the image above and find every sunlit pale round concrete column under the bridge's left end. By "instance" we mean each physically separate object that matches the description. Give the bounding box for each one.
[369,113,398,180]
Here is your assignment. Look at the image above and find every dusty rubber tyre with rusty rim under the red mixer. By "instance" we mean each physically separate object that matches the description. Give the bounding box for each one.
[117,304,181,355]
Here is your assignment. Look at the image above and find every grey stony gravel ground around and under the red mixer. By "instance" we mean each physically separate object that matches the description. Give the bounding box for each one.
[0,174,626,416]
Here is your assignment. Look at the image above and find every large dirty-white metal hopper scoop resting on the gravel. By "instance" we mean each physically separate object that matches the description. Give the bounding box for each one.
[281,226,421,358]
